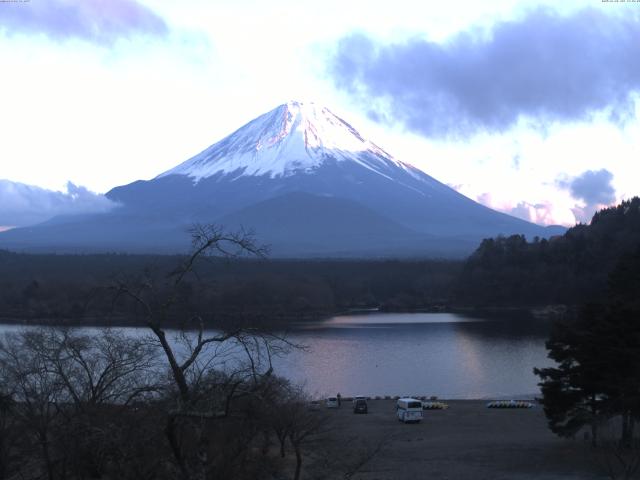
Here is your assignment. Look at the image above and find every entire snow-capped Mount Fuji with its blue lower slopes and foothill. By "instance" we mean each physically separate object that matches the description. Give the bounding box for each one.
[0,102,563,257]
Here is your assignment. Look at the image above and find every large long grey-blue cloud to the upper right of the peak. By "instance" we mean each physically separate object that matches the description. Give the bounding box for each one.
[328,9,640,137]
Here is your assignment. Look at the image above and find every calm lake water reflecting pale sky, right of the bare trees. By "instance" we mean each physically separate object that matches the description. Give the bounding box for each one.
[0,313,551,398]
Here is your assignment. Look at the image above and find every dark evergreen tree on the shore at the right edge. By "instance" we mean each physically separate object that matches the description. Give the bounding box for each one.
[534,250,640,445]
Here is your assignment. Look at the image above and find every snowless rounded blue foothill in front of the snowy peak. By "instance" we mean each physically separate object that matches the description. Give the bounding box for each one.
[220,192,472,257]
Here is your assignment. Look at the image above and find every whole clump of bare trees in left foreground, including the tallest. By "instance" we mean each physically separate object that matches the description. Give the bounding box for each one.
[0,227,318,480]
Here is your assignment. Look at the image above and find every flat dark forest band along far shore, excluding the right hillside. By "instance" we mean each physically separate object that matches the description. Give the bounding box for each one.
[0,251,461,325]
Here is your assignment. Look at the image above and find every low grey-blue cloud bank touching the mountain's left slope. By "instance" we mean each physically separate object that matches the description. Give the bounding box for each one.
[0,180,117,228]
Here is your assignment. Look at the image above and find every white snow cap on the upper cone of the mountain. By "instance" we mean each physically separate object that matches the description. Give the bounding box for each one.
[156,101,419,182]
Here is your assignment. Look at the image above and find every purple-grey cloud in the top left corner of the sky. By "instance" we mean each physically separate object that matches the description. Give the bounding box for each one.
[0,0,169,45]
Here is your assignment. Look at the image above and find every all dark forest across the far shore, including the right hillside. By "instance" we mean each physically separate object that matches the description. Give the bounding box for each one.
[0,197,640,326]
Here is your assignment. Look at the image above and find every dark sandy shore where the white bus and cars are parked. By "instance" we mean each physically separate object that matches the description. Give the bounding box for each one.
[307,400,605,480]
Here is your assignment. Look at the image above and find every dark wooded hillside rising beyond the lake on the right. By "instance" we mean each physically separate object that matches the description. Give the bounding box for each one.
[452,197,640,307]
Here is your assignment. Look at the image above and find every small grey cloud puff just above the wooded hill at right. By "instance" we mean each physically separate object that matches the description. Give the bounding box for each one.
[556,168,616,222]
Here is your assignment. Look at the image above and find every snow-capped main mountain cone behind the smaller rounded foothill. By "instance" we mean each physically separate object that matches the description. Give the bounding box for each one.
[108,102,559,239]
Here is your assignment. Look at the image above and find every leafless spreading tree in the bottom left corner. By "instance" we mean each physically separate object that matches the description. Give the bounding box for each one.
[0,328,158,479]
